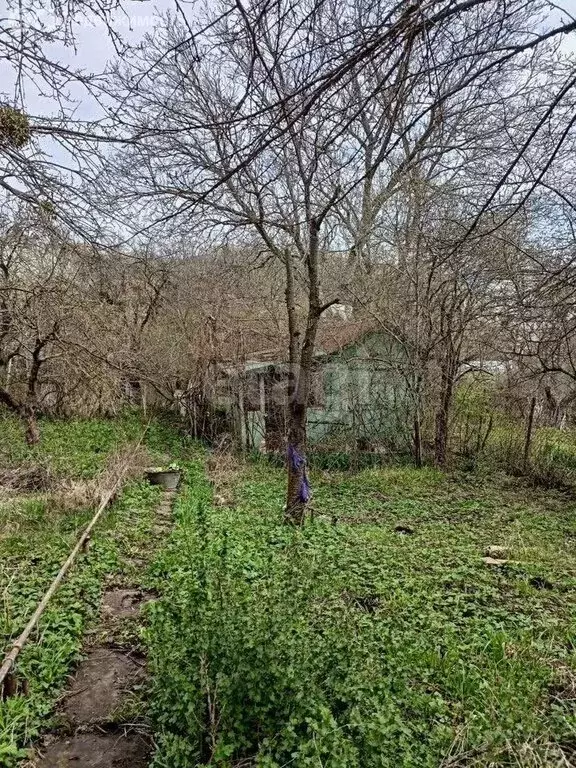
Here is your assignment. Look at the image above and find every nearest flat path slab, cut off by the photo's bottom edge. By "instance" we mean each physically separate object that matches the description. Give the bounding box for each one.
[35,733,150,768]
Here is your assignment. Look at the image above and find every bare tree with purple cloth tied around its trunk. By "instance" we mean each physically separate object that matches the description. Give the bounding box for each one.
[105,9,354,523]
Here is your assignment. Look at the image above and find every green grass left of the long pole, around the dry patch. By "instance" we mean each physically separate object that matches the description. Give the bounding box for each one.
[0,418,143,652]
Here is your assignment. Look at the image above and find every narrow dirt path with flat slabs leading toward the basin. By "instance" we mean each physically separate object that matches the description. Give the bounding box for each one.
[31,491,175,768]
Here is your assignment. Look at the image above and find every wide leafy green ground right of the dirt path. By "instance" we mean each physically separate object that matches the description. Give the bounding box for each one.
[148,462,576,768]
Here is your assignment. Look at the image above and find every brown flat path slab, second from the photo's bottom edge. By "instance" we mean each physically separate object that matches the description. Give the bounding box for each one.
[64,648,144,728]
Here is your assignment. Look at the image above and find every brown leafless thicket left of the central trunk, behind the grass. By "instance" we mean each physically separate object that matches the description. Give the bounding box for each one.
[0,206,285,443]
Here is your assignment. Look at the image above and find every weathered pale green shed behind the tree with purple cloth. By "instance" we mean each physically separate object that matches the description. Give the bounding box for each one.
[220,323,411,451]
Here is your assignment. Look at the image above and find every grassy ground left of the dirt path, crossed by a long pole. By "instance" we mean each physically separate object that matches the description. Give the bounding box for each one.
[0,416,178,768]
